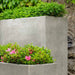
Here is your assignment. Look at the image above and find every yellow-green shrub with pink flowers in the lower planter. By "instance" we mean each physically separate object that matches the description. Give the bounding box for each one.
[0,43,54,64]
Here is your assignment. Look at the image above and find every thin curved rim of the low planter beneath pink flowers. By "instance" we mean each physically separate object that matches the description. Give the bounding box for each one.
[0,62,56,66]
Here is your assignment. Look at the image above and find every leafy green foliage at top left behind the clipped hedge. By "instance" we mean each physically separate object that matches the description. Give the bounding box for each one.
[0,0,41,12]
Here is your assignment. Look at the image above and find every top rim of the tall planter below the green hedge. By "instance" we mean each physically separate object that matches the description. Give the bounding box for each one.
[0,16,67,21]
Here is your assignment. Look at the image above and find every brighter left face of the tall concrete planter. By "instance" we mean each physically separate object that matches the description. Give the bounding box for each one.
[0,17,45,46]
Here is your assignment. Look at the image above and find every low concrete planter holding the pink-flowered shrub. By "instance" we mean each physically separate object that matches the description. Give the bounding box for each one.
[0,63,57,75]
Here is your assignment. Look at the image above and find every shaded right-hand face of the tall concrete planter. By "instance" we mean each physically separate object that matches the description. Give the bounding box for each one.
[46,17,67,75]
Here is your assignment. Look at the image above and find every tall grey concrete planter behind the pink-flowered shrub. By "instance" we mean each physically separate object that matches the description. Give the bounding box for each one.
[0,16,67,75]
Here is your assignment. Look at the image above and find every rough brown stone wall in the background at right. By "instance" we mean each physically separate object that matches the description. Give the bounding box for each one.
[42,0,75,75]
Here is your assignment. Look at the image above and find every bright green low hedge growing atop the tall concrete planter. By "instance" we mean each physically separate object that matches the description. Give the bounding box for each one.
[0,2,66,20]
